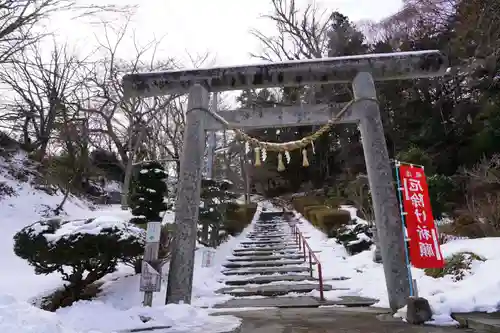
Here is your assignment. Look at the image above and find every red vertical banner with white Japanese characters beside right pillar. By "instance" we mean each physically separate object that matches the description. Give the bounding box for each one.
[398,164,444,268]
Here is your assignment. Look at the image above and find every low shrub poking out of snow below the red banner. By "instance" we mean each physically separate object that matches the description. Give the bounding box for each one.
[424,251,486,282]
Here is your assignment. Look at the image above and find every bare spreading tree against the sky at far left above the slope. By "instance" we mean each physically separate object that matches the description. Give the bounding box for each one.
[0,37,84,161]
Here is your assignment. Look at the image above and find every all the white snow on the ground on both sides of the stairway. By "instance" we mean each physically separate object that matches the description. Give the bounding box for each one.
[6,147,500,333]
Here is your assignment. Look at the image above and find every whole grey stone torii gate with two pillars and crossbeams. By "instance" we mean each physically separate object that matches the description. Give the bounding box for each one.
[122,51,447,311]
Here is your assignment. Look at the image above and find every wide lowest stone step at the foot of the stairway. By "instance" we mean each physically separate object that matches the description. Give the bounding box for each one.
[214,296,378,309]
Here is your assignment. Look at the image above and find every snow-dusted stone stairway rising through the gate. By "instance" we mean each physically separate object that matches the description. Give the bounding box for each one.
[211,212,376,308]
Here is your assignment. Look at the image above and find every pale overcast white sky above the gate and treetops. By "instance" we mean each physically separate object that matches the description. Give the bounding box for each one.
[52,0,402,65]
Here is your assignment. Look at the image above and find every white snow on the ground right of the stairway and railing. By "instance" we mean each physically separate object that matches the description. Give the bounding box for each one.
[297,206,500,325]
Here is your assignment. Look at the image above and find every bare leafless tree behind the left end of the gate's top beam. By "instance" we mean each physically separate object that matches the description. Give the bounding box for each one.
[80,17,175,209]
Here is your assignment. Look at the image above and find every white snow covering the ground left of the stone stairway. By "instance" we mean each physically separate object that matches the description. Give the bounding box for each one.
[0,153,242,333]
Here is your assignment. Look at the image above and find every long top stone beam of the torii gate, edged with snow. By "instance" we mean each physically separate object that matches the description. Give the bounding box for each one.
[123,50,448,97]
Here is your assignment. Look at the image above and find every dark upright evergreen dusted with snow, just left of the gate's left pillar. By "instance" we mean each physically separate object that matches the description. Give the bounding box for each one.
[131,161,168,224]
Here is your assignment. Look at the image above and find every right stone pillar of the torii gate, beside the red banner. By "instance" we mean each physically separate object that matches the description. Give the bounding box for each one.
[352,72,410,311]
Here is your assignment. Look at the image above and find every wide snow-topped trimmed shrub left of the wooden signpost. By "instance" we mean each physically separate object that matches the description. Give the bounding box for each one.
[14,217,146,308]
